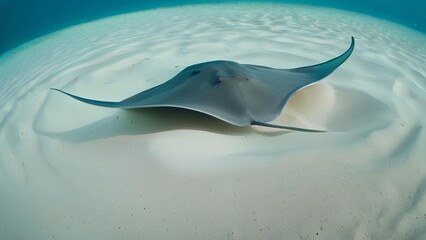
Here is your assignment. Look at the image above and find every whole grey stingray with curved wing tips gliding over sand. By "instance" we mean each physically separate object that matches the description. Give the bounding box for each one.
[52,37,355,132]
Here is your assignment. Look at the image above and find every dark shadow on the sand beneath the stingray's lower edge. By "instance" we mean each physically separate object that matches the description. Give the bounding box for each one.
[34,107,290,143]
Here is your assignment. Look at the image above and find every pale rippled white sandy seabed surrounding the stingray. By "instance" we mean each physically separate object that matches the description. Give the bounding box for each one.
[0,4,426,240]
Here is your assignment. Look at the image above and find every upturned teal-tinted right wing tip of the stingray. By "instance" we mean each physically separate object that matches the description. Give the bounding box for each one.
[290,37,355,82]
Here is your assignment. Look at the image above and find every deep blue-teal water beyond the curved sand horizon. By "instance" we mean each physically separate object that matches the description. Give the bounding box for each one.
[0,0,426,54]
